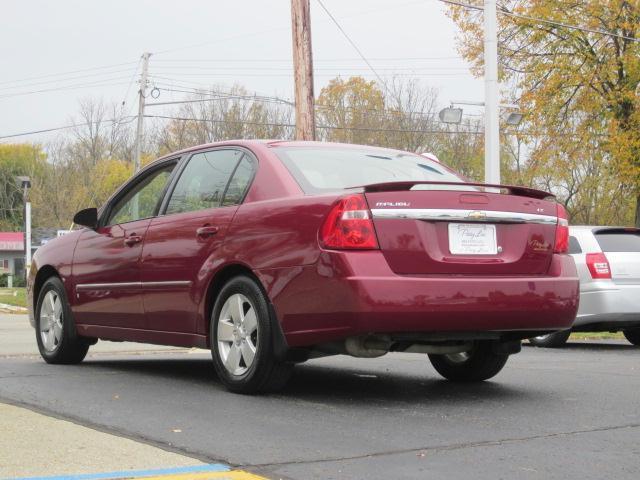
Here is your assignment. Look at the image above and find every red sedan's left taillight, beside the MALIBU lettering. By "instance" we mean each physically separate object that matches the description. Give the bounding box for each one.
[320,195,378,250]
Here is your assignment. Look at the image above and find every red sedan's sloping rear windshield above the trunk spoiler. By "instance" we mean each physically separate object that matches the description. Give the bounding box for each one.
[274,147,464,193]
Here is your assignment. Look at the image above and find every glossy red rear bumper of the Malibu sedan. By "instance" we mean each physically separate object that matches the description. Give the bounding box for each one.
[261,251,579,346]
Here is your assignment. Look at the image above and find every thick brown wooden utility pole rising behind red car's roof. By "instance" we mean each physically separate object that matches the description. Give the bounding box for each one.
[291,0,316,140]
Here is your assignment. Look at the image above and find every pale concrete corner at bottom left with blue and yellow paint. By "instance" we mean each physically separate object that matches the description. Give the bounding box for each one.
[0,403,261,480]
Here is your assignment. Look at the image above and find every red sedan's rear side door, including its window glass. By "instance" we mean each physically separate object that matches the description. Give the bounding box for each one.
[141,148,257,333]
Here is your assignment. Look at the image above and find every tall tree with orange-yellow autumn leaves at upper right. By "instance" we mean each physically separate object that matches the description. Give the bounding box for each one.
[449,0,640,226]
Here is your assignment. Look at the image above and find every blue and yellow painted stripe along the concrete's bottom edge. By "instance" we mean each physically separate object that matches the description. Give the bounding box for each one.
[6,463,267,480]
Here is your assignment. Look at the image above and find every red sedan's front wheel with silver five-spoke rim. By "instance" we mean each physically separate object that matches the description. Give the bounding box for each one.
[35,277,92,365]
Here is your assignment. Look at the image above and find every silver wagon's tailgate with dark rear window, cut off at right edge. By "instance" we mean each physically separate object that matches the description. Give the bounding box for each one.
[593,228,640,285]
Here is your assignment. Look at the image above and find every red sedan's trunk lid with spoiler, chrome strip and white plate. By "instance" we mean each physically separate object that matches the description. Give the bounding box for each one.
[364,182,558,275]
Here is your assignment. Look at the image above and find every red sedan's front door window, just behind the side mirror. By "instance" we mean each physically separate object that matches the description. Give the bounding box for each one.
[106,163,176,225]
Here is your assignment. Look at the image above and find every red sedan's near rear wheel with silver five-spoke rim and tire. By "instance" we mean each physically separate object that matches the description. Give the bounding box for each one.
[209,275,293,394]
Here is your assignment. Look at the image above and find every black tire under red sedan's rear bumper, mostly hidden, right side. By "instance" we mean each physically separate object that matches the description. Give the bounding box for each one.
[429,342,509,382]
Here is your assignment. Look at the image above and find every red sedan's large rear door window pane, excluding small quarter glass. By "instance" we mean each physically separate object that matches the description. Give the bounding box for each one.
[166,149,244,215]
